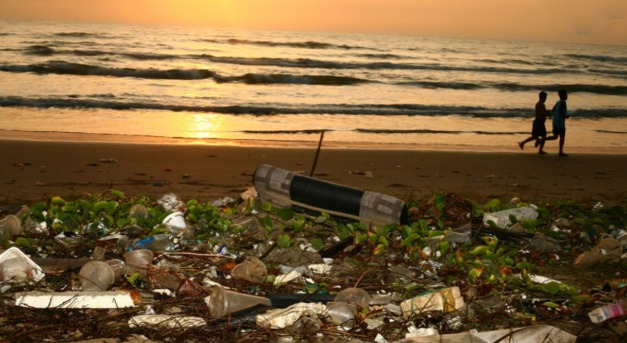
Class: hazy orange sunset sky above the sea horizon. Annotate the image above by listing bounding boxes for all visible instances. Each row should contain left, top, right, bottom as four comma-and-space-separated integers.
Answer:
0, 0, 627, 46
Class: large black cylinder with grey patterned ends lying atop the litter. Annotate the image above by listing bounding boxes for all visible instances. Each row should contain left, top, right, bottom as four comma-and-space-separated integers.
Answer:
253, 164, 407, 225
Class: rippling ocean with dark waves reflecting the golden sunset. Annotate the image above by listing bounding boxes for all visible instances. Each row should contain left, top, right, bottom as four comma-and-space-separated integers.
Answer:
0, 21, 627, 153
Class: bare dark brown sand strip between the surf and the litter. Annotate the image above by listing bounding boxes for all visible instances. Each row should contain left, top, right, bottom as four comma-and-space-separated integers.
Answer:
0, 133, 627, 211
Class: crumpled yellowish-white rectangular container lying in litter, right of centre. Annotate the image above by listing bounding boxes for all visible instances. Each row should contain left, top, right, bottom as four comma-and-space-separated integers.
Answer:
401, 287, 465, 317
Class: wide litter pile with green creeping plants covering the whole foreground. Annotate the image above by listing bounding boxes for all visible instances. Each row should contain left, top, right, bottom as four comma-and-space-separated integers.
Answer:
0, 167, 627, 342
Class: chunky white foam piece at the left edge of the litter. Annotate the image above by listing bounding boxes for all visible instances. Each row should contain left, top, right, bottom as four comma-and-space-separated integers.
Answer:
0, 247, 46, 282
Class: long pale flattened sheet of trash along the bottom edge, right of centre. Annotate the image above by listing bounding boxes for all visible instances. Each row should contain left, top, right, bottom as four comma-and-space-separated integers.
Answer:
398, 325, 577, 343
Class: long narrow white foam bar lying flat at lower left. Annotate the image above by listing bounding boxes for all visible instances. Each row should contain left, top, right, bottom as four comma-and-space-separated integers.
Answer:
15, 291, 135, 308
